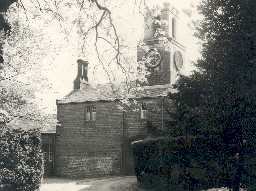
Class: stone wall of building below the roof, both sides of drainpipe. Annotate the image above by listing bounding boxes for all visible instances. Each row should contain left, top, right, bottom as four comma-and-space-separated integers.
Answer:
55, 99, 172, 177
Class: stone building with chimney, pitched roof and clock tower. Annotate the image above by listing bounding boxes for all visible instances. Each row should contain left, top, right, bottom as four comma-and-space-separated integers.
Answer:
55, 5, 186, 177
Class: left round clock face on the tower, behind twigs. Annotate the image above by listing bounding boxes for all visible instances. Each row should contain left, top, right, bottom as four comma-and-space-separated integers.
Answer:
145, 48, 162, 68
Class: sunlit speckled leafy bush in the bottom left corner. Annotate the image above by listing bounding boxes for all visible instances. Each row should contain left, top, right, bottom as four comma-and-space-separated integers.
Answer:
0, 124, 43, 191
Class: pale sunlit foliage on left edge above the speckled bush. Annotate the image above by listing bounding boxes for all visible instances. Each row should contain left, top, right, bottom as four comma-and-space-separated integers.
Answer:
0, 0, 47, 116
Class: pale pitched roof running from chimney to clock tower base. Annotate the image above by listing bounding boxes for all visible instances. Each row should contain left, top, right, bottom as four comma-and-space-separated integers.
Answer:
57, 84, 174, 104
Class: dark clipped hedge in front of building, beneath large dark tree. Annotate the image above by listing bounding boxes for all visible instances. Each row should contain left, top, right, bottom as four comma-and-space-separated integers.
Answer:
132, 137, 256, 191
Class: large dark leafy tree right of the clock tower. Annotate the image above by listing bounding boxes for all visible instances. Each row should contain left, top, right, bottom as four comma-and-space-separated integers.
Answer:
173, 0, 256, 191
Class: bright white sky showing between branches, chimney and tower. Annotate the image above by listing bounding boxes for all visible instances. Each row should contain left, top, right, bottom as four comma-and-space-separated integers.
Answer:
7, 0, 202, 113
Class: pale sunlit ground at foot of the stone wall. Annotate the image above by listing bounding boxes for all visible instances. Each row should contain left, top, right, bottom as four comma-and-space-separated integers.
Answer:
40, 176, 137, 191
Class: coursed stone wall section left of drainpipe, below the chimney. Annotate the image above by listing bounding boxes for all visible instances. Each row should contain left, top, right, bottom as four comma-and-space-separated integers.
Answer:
56, 102, 122, 177
